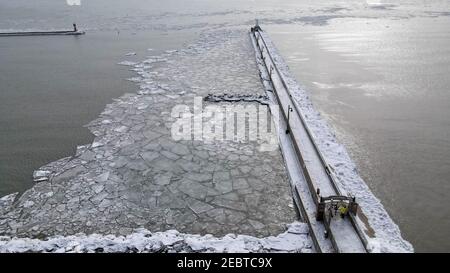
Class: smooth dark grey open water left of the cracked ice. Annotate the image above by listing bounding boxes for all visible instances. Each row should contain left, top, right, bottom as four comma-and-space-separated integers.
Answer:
0, 31, 195, 195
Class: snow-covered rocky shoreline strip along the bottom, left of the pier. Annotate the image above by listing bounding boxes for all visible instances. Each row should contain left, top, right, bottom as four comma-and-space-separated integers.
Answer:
0, 222, 313, 253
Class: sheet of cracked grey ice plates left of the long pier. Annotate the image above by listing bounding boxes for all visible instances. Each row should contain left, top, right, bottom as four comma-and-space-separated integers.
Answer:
0, 29, 296, 238
